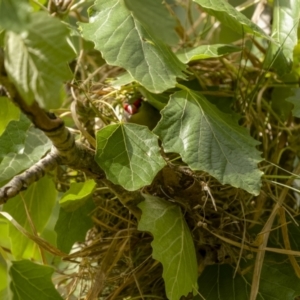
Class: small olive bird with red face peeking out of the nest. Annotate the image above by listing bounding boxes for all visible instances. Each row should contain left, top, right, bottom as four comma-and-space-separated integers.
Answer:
123, 98, 160, 130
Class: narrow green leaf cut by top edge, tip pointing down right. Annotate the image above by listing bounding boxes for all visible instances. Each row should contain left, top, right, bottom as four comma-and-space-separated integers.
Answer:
194, 0, 271, 40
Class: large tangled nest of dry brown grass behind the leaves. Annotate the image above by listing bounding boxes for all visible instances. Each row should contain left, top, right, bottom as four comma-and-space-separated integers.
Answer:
55, 35, 300, 300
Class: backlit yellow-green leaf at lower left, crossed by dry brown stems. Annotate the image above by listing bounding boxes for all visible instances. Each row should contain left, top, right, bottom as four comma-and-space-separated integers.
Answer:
3, 176, 57, 259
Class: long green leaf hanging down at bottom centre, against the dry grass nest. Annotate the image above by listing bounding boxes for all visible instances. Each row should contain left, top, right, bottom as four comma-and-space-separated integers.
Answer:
138, 195, 197, 300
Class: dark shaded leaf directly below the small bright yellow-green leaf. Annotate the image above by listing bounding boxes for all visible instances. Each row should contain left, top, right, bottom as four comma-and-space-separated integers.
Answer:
55, 199, 95, 253
